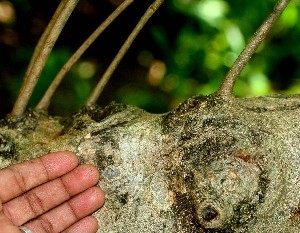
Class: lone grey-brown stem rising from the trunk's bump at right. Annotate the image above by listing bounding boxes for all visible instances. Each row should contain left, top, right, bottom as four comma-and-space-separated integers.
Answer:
216, 0, 290, 98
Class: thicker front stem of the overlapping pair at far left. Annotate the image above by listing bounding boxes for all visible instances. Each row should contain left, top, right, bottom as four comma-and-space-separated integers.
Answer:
11, 0, 79, 117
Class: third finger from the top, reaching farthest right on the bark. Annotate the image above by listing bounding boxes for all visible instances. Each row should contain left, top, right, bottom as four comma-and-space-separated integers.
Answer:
25, 187, 104, 233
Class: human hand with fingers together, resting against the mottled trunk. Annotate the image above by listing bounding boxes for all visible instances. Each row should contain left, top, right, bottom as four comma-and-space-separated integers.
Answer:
0, 151, 104, 233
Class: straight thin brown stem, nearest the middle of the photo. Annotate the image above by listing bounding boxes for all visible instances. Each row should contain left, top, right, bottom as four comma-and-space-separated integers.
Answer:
85, 0, 164, 106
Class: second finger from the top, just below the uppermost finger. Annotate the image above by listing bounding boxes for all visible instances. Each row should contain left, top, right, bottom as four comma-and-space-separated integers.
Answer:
3, 165, 99, 225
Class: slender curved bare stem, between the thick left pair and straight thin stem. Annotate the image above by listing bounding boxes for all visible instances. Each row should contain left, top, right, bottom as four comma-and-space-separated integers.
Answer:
35, 0, 134, 110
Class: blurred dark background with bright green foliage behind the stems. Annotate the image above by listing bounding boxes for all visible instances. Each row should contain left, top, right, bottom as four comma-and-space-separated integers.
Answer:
0, 0, 300, 116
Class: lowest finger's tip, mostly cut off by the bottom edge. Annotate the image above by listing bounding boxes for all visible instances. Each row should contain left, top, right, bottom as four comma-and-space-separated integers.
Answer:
62, 216, 98, 233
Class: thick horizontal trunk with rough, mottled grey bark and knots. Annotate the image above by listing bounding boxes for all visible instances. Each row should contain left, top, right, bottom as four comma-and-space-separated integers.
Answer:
0, 95, 300, 233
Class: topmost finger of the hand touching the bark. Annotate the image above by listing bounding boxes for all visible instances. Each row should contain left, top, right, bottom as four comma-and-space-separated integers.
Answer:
0, 151, 78, 203
